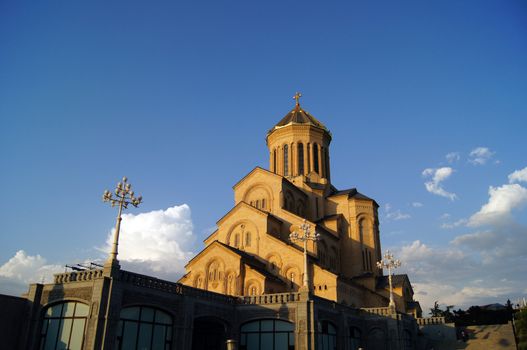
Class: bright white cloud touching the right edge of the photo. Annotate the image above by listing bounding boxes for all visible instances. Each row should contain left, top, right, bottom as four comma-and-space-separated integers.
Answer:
468, 184, 527, 226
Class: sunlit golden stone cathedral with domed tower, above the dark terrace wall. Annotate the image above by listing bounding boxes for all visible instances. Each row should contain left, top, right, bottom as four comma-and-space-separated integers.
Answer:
180, 94, 420, 315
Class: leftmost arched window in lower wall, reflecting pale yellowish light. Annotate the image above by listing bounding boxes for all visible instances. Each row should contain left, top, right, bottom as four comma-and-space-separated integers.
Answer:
40, 301, 89, 350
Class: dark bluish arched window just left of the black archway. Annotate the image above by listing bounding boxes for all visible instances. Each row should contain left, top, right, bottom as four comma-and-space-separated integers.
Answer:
115, 306, 172, 350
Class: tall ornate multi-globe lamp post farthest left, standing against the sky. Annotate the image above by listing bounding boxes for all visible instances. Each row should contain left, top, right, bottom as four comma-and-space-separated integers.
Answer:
102, 176, 143, 266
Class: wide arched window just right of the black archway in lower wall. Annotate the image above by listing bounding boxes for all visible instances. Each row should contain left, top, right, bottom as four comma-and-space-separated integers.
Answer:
240, 320, 295, 350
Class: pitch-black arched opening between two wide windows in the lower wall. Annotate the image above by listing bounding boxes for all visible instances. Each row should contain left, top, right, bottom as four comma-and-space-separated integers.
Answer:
192, 317, 228, 350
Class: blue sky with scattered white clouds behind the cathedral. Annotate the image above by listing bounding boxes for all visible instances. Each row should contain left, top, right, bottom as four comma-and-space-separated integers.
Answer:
0, 0, 527, 307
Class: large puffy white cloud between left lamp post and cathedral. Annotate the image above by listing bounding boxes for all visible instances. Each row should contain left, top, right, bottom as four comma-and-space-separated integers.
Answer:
105, 204, 196, 279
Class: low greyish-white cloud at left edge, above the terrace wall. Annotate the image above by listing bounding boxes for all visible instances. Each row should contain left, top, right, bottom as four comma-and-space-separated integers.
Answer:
0, 250, 64, 294
